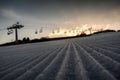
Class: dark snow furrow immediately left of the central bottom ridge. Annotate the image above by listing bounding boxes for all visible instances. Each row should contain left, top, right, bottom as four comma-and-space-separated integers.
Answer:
35, 41, 70, 80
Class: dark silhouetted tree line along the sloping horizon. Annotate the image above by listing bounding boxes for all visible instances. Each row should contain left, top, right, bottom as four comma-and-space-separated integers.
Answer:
0, 29, 120, 46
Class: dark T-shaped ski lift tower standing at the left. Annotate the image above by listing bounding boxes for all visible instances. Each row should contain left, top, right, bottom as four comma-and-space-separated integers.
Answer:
7, 22, 24, 42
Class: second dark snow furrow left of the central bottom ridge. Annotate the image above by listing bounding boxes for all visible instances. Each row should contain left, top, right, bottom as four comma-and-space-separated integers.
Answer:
15, 42, 69, 80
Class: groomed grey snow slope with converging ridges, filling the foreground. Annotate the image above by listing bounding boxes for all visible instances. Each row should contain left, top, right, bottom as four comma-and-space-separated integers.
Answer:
0, 32, 120, 80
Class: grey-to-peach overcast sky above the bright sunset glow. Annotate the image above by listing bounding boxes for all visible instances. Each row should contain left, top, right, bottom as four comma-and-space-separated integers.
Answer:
0, 0, 120, 42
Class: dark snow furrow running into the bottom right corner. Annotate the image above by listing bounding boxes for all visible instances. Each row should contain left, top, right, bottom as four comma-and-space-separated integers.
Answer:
79, 45, 120, 78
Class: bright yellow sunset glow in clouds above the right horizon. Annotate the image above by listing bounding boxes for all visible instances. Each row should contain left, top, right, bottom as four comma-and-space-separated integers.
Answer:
48, 24, 116, 38
